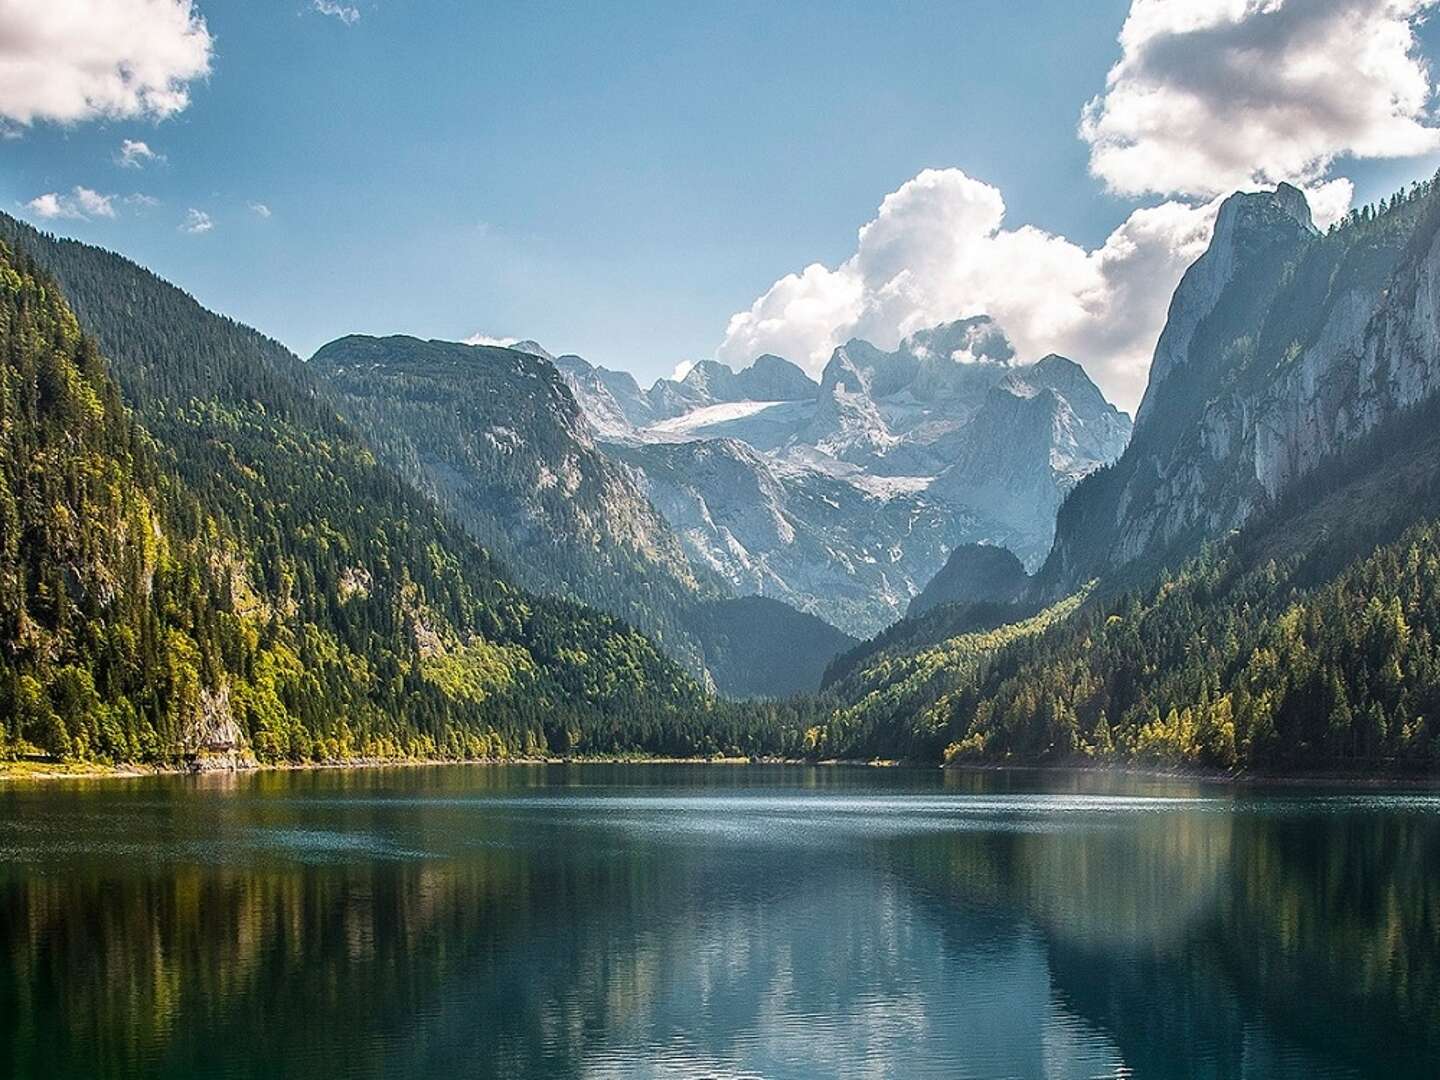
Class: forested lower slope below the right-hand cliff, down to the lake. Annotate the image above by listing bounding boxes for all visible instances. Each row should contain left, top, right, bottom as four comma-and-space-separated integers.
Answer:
808, 388, 1440, 772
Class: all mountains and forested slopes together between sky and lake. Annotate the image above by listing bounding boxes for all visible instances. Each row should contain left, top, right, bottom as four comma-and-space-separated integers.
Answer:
8, 183, 1440, 772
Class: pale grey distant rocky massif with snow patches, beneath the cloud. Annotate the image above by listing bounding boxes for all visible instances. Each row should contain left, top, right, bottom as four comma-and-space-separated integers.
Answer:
544, 315, 1130, 635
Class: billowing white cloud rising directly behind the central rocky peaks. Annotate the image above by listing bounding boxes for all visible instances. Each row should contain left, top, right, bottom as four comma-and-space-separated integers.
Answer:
717, 168, 1238, 408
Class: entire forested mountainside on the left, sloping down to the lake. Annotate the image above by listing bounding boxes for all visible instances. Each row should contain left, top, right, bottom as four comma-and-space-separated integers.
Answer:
0, 217, 794, 760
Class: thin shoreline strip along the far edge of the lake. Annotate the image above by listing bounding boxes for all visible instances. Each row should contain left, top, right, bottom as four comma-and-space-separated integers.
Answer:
0, 755, 1440, 789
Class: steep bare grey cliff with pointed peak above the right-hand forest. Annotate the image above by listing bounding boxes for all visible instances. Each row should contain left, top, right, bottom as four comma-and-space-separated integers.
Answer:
1040, 184, 1440, 592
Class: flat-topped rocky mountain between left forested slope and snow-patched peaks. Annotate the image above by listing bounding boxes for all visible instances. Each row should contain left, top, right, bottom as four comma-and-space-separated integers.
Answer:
310, 334, 726, 677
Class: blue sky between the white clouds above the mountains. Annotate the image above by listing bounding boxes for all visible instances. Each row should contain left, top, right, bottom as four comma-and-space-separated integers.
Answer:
8, 0, 1437, 408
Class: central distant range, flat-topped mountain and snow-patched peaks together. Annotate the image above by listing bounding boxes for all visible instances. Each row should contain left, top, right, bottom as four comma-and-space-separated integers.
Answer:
298, 318, 1129, 693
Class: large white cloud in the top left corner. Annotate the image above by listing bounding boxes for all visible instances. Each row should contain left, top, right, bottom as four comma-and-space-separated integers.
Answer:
0, 0, 213, 125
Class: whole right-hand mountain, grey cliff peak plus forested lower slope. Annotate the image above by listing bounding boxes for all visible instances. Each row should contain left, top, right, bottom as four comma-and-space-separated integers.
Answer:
812, 181, 1440, 772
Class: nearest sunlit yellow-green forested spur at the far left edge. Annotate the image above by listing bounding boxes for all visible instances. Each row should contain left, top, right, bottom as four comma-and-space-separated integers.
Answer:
0, 237, 239, 760
